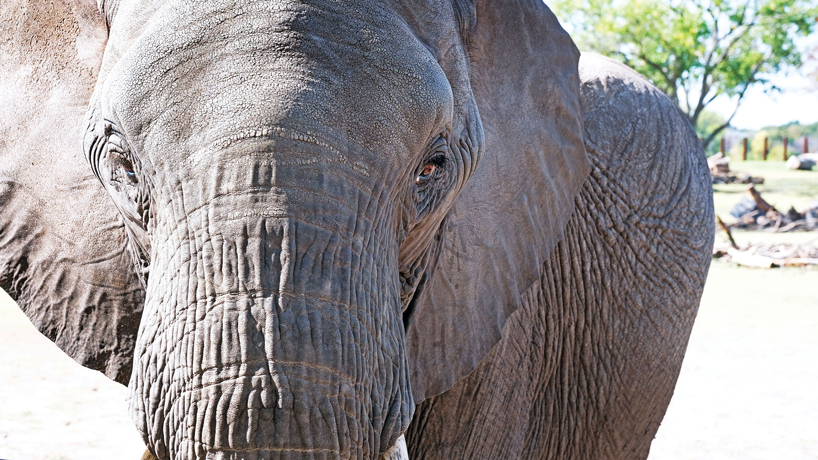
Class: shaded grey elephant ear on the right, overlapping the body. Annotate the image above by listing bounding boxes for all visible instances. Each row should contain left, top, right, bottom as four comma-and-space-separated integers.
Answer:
406, 0, 589, 403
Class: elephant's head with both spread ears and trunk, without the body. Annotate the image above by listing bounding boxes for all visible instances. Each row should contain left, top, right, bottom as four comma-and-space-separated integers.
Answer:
0, 0, 588, 459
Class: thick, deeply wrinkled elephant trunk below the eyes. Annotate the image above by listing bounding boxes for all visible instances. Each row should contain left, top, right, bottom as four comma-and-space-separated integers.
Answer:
130, 174, 414, 459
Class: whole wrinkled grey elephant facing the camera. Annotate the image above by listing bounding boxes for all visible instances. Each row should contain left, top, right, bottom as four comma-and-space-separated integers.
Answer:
0, 0, 714, 460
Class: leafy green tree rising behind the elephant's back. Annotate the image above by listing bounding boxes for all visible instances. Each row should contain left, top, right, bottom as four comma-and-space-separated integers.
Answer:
549, 0, 818, 148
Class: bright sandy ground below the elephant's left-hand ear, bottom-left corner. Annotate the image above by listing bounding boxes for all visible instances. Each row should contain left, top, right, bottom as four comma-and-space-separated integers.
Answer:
0, 290, 145, 460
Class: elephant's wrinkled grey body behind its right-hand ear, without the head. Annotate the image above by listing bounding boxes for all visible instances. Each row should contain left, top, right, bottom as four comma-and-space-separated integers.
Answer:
407, 54, 713, 459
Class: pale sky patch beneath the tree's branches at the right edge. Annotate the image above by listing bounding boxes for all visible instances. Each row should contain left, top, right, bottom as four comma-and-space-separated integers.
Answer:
708, 73, 818, 130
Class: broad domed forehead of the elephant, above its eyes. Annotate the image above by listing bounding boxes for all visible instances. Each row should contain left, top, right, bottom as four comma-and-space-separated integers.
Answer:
105, 1, 454, 162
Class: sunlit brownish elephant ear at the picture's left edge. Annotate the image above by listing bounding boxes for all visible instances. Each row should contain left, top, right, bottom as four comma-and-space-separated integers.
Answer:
0, 0, 144, 384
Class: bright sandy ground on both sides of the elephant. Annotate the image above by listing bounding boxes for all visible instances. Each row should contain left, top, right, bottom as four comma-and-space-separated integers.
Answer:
0, 262, 818, 460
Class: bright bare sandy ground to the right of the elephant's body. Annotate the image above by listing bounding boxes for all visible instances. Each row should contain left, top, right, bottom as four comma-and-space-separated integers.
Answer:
649, 261, 818, 460
